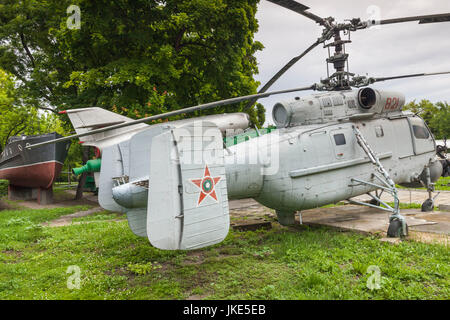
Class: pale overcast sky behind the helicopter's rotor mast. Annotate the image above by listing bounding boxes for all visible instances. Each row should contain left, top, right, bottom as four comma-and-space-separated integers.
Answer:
255, 0, 450, 124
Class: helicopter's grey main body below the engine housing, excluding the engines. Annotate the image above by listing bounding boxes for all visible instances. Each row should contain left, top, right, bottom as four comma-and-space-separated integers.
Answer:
225, 112, 435, 211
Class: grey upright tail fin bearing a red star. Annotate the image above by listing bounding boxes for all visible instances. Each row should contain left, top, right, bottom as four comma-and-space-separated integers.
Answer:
147, 121, 230, 250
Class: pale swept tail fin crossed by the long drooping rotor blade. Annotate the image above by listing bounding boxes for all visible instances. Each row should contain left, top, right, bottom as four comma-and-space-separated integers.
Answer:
66, 107, 148, 150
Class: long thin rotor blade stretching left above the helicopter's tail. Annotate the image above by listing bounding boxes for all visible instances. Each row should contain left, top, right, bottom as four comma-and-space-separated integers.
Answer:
26, 84, 316, 149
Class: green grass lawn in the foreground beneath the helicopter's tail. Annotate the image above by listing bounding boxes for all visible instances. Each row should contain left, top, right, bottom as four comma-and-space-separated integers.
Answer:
0, 207, 450, 299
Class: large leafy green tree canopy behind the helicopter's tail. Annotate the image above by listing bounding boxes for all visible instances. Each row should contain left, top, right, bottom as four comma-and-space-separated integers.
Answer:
0, 0, 264, 124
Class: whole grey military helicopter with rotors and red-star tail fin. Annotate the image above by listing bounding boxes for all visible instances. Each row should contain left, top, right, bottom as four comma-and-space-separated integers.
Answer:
29, 0, 450, 250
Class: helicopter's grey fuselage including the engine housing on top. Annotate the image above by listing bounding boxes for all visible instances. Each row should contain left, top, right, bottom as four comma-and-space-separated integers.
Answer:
225, 88, 440, 222
